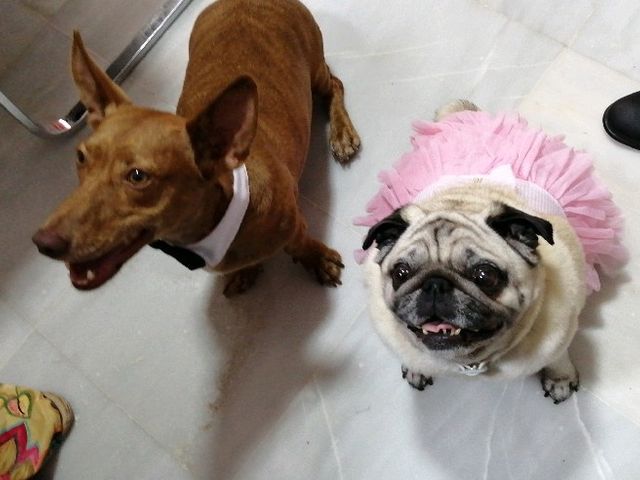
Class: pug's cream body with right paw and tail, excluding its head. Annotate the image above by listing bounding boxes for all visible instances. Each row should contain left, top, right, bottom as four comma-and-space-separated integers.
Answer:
364, 101, 586, 402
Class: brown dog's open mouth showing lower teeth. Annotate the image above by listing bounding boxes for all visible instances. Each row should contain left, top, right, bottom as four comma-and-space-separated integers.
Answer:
67, 230, 152, 290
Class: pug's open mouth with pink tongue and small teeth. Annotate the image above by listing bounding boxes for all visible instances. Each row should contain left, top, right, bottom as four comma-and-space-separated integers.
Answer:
405, 318, 502, 350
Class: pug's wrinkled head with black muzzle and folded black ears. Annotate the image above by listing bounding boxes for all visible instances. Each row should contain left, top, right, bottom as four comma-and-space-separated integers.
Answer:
363, 204, 553, 357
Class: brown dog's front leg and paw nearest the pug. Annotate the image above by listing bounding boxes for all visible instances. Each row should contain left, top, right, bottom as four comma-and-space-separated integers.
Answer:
284, 214, 344, 287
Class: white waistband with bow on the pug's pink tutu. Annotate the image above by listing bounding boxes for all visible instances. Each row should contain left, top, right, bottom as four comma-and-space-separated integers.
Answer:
414, 165, 565, 217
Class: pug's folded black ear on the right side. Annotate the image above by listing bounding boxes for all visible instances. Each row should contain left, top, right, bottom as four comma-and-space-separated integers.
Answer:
487, 205, 553, 264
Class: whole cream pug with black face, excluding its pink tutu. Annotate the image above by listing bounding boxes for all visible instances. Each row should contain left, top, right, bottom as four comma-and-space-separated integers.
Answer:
363, 102, 587, 404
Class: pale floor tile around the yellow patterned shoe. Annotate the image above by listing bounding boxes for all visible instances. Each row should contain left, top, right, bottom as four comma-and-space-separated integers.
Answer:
0, 333, 192, 480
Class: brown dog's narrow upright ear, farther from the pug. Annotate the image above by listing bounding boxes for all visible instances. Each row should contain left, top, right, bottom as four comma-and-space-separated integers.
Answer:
71, 30, 131, 129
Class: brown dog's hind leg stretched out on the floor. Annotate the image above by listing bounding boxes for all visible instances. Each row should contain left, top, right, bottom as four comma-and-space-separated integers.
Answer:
314, 62, 360, 164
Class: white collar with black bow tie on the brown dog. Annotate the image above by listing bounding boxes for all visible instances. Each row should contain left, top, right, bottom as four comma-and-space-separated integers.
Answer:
149, 163, 251, 270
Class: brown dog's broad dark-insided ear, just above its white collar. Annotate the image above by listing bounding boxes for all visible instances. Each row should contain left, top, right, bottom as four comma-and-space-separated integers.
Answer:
187, 77, 258, 178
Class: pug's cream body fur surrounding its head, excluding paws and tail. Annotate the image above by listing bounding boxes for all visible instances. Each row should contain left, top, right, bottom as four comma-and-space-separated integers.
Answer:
364, 185, 586, 378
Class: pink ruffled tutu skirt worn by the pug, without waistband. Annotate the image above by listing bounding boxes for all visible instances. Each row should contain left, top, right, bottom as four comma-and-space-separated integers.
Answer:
354, 111, 627, 291
